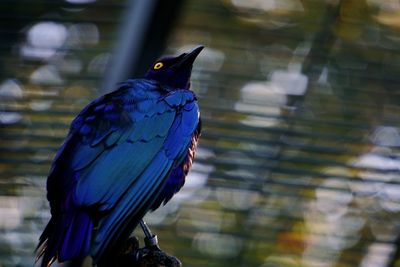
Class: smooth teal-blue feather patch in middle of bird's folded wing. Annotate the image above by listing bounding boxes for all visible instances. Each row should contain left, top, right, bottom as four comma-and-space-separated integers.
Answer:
74, 137, 164, 210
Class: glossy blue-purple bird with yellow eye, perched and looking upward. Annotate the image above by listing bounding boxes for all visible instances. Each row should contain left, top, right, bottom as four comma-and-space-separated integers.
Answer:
36, 46, 204, 267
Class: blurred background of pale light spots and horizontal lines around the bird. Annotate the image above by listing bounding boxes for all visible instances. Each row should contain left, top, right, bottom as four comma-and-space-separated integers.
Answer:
0, 0, 400, 267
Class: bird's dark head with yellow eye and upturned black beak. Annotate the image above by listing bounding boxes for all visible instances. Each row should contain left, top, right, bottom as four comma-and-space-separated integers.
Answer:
144, 46, 204, 89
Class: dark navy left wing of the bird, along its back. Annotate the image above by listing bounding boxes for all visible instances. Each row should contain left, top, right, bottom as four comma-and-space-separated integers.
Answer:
47, 85, 135, 215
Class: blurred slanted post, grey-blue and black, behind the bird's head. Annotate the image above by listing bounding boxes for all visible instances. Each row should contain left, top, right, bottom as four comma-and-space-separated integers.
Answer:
101, 0, 183, 93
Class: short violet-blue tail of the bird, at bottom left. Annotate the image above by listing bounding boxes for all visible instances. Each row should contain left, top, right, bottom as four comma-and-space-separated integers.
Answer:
36, 210, 93, 267
